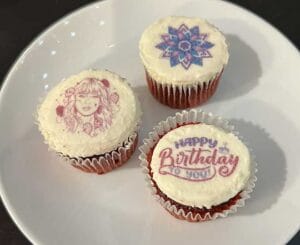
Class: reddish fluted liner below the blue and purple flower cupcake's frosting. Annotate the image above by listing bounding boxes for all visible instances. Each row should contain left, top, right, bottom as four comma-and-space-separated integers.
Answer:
145, 70, 223, 109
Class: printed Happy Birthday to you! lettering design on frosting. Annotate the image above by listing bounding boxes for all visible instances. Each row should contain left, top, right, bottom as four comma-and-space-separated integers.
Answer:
159, 137, 239, 181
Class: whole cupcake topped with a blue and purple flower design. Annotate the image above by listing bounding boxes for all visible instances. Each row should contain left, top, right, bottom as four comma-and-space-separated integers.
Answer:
139, 16, 229, 109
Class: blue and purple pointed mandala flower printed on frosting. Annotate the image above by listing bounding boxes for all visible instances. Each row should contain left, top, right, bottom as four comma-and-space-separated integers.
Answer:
155, 24, 214, 70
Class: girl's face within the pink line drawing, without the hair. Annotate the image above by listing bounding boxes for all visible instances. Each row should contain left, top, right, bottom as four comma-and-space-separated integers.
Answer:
75, 93, 100, 116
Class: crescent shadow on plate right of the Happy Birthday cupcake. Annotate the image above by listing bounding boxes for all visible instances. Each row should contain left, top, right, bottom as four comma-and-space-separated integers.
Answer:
230, 119, 287, 215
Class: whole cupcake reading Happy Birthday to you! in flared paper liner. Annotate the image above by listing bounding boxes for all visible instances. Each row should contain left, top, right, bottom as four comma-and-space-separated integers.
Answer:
140, 110, 256, 222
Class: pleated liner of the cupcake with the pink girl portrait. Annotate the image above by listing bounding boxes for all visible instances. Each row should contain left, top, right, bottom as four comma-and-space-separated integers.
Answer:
58, 132, 138, 174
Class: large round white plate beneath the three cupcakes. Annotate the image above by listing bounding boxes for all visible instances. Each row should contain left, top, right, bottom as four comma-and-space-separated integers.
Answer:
0, 0, 300, 245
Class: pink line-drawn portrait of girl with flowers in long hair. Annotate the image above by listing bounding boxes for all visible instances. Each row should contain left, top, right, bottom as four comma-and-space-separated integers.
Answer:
56, 78, 119, 137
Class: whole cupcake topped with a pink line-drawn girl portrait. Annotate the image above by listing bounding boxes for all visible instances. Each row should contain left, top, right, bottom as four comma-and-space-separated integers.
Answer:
36, 70, 141, 174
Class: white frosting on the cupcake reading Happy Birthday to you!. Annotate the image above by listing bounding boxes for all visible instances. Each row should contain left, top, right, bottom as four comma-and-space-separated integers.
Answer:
151, 124, 251, 208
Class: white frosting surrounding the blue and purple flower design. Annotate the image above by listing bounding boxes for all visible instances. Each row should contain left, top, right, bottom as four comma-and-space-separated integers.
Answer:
139, 16, 229, 85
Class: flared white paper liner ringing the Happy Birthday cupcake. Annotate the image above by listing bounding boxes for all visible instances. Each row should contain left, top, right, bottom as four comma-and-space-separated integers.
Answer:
139, 109, 257, 222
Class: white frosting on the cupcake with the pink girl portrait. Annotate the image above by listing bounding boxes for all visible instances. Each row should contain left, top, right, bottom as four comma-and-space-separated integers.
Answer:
37, 70, 141, 157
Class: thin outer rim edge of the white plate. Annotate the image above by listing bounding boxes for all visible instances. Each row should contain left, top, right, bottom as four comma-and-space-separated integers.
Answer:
0, 0, 300, 244
